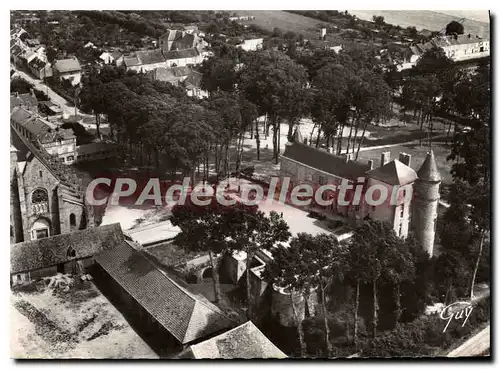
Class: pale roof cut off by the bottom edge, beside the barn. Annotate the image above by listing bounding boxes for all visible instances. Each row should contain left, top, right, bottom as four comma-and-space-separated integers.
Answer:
182, 321, 287, 359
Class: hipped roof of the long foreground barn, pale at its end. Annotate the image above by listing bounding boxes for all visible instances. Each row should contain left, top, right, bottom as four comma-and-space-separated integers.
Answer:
95, 243, 233, 344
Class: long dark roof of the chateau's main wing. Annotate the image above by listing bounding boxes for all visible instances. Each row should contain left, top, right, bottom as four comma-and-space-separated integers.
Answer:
283, 142, 370, 179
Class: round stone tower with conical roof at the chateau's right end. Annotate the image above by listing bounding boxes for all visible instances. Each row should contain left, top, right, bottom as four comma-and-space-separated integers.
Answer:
412, 150, 441, 256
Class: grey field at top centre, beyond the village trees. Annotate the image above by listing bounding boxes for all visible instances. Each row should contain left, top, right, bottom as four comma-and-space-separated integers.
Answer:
235, 10, 321, 39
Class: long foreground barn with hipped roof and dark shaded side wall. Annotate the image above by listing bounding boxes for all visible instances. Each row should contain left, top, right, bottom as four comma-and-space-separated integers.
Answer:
94, 242, 235, 356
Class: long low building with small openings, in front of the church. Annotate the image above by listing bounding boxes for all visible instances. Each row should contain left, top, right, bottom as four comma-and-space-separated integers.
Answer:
10, 223, 125, 285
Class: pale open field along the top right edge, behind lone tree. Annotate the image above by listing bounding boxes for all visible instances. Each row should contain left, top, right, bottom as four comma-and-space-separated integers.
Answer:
349, 10, 489, 37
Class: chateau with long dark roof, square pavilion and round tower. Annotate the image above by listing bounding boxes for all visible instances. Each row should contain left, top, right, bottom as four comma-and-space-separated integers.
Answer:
280, 130, 441, 256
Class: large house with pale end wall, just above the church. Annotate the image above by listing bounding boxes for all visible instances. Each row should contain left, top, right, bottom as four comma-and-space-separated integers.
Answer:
10, 107, 77, 164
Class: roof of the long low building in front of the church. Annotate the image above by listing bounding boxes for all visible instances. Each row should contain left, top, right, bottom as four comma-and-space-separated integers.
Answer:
10, 223, 125, 274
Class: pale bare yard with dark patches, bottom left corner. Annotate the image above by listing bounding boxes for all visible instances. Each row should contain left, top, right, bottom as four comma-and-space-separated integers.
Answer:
10, 281, 158, 359
